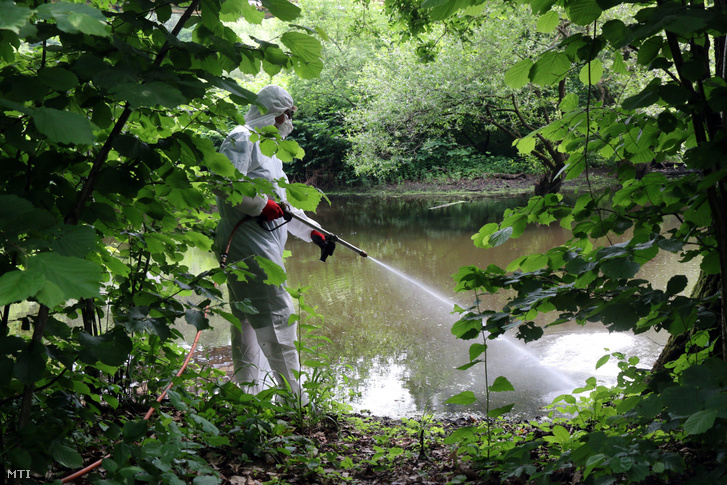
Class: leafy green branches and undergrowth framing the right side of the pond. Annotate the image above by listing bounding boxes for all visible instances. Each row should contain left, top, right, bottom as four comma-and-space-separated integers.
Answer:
392, 0, 727, 483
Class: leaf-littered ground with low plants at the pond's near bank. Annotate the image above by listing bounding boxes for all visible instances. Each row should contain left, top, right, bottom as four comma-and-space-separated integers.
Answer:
208, 414, 540, 485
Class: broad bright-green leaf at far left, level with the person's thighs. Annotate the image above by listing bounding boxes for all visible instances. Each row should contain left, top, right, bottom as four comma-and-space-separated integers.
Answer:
27, 253, 102, 299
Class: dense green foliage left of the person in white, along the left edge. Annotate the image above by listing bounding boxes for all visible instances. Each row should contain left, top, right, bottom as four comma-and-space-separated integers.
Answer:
0, 0, 322, 480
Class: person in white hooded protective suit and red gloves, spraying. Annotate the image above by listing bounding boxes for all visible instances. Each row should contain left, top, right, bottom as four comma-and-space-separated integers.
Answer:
215, 85, 333, 404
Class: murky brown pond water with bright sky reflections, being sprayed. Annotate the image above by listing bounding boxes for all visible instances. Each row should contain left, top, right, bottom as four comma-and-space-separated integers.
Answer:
180, 196, 698, 417
